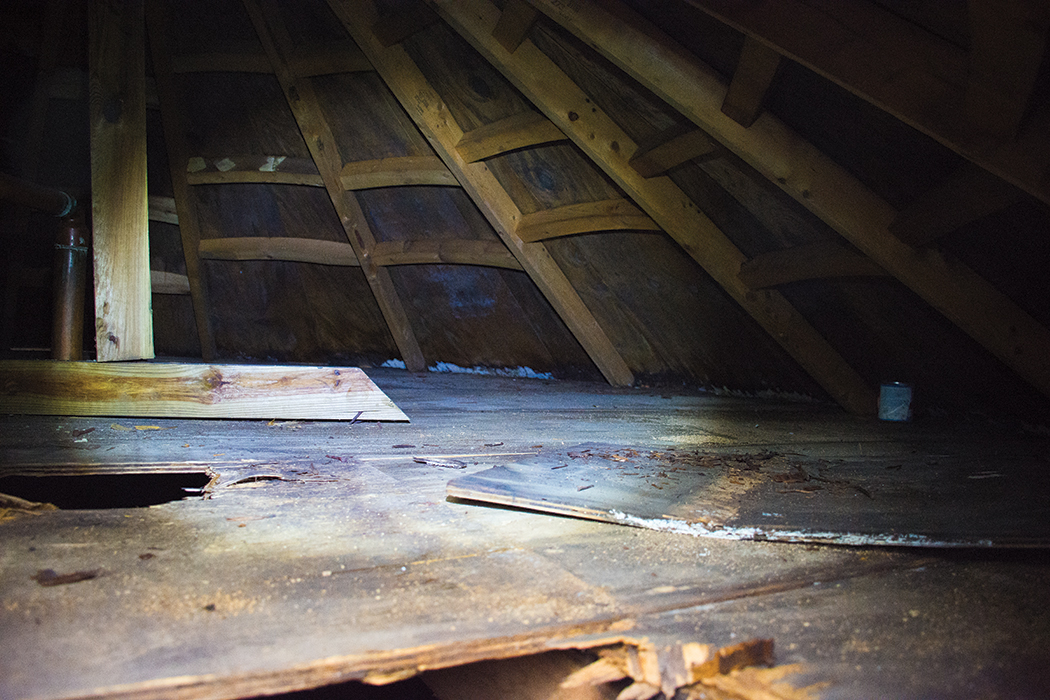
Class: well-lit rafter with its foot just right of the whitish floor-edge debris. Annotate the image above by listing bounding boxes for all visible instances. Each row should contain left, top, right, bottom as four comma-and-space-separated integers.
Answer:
329, 0, 634, 385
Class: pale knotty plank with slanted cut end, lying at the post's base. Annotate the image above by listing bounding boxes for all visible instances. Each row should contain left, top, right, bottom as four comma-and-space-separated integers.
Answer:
0, 360, 408, 421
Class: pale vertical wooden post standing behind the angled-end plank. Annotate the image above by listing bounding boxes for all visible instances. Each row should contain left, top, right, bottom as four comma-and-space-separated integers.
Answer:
88, 0, 153, 361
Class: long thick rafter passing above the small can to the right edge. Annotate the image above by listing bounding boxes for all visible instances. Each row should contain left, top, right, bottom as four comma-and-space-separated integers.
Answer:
533, 0, 1050, 405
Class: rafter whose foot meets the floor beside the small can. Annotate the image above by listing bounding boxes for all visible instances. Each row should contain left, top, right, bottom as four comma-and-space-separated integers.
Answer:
437, 0, 875, 413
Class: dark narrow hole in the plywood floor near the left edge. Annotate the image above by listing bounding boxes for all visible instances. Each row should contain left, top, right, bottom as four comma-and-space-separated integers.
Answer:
0, 471, 210, 510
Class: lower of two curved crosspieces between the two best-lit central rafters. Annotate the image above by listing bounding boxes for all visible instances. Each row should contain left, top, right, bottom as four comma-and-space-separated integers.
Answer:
515, 197, 660, 242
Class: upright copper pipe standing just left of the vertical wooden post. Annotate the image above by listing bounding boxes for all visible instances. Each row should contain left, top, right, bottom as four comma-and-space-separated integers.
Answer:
51, 212, 87, 360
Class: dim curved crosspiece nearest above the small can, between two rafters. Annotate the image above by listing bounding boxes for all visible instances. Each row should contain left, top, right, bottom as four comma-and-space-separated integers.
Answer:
740, 240, 888, 290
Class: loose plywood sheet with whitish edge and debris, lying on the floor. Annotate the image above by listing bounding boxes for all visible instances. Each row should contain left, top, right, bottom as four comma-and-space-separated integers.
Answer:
447, 444, 1050, 547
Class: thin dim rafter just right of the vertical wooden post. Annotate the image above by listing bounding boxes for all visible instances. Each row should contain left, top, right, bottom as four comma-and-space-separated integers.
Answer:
146, 0, 216, 360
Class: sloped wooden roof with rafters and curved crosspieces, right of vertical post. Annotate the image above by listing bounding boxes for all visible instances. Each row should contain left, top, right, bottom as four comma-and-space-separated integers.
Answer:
2, 0, 1050, 420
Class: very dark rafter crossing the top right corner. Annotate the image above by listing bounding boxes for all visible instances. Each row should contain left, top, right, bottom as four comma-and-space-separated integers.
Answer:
680, 0, 1050, 204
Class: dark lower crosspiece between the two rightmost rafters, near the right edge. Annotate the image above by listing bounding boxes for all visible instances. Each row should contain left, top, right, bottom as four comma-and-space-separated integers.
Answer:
889, 163, 1024, 246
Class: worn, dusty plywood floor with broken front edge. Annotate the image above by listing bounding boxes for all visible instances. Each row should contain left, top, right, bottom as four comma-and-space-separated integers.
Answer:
0, 370, 1050, 700
